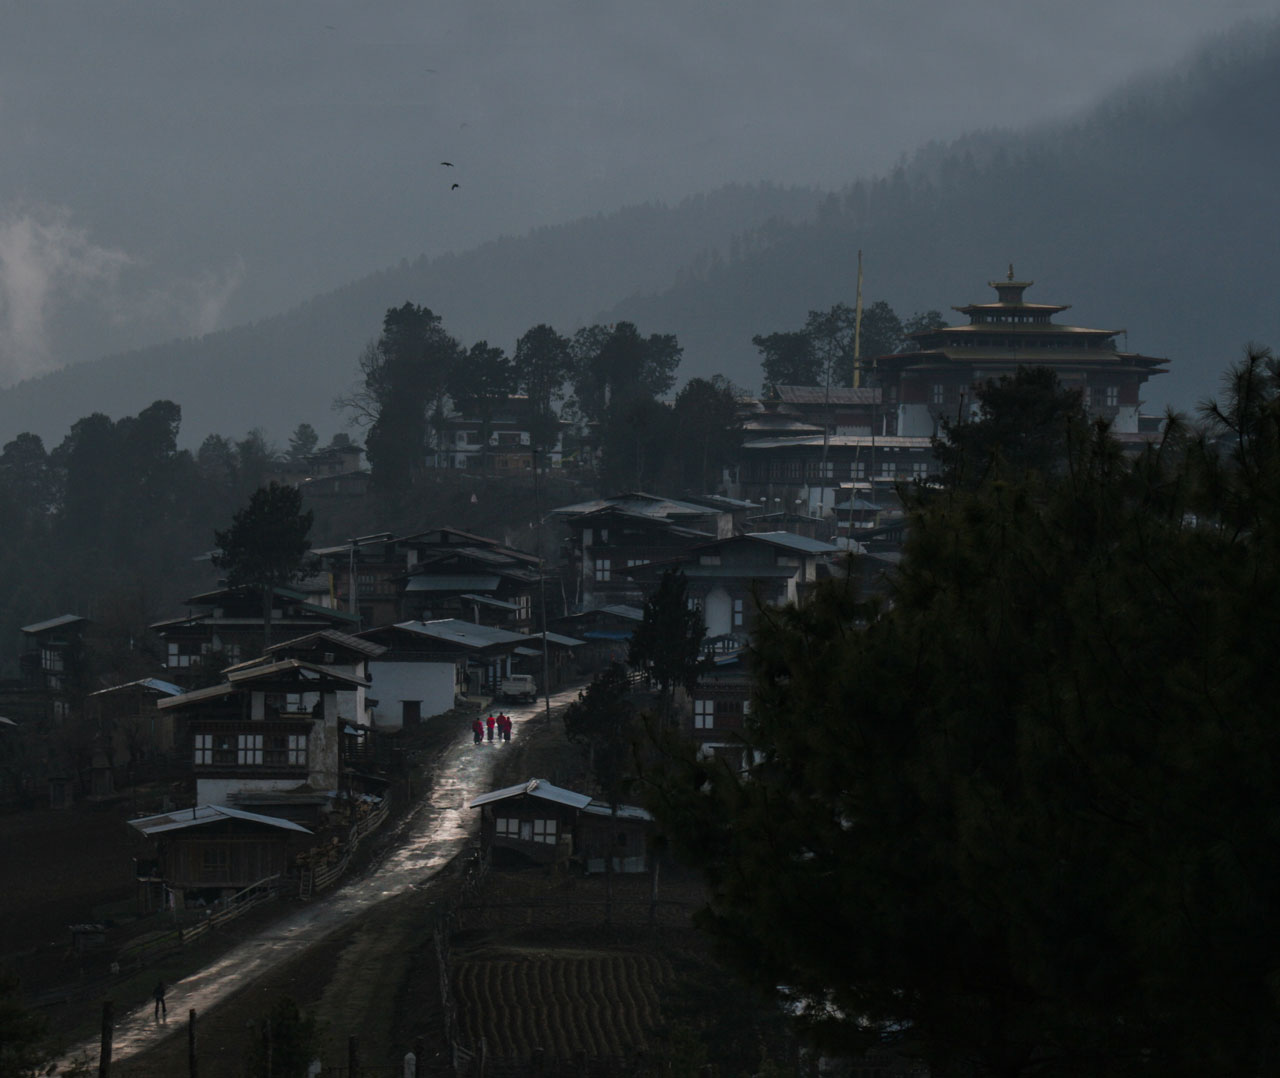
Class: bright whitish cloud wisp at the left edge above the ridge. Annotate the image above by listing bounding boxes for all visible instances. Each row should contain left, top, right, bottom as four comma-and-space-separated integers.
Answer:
0, 206, 132, 382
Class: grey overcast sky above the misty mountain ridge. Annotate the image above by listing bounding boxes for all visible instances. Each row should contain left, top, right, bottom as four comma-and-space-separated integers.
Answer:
0, 0, 1280, 384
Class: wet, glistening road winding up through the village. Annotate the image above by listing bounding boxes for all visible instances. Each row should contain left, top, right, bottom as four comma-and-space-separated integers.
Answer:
61, 688, 579, 1066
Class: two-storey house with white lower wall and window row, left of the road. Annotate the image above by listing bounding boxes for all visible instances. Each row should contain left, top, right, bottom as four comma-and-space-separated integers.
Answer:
159, 659, 369, 826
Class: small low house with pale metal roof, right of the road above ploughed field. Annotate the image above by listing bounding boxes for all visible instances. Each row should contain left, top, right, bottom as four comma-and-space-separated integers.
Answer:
470, 778, 652, 872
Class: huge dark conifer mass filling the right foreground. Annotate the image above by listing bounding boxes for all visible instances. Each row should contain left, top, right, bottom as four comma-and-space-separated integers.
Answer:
640, 348, 1280, 1078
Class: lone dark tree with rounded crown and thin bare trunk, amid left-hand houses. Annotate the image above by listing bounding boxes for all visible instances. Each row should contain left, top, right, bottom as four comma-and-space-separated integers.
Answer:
214, 483, 314, 649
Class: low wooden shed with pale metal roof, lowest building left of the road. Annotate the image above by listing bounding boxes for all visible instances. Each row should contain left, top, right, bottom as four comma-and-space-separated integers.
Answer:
129, 804, 312, 909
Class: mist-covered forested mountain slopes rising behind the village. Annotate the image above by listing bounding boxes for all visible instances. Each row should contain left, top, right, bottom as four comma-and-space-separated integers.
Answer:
0, 27, 1280, 443
